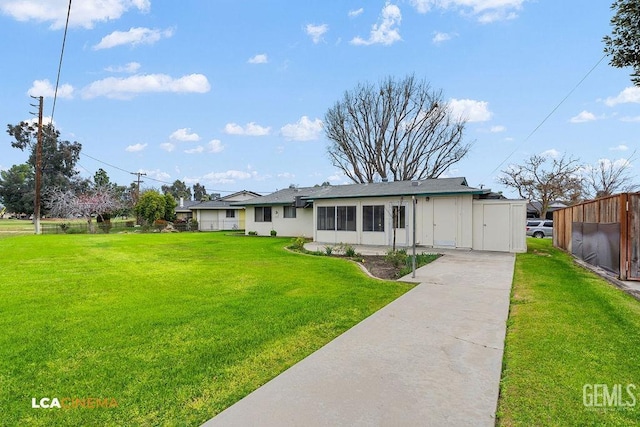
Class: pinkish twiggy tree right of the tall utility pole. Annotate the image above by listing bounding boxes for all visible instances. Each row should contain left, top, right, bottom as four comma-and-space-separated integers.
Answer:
45, 187, 122, 233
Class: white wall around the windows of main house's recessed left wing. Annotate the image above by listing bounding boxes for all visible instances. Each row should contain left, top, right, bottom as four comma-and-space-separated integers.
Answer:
245, 206, 314, 237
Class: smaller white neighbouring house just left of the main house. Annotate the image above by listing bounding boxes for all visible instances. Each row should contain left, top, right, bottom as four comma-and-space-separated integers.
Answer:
190, 190, 260, 231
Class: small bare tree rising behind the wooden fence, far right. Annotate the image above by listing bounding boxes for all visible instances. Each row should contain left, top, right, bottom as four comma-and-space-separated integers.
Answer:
584, 151, 638, 198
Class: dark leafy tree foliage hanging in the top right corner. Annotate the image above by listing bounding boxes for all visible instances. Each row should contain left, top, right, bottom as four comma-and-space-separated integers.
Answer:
603, 0, 640, 86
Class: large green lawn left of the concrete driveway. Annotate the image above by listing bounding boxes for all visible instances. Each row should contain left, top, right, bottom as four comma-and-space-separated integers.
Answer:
0, 233, 410, 426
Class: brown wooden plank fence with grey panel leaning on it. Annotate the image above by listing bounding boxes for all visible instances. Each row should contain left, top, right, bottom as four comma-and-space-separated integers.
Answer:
553, 193, 640, 280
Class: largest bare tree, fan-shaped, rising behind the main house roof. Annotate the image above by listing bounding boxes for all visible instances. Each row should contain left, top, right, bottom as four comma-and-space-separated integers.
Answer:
325, 76, 471, 183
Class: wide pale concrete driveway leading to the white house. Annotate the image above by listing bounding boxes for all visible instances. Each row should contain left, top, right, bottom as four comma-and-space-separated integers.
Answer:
204, 250, 515, 427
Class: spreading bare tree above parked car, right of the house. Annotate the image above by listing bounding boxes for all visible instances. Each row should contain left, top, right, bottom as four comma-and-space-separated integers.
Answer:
498, 155, 582, 218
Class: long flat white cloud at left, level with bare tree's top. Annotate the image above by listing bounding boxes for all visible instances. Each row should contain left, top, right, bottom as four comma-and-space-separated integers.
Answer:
82, 74, 211, 99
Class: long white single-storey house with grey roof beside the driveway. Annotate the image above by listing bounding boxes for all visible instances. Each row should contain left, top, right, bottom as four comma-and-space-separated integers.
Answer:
244, 178, 527, 252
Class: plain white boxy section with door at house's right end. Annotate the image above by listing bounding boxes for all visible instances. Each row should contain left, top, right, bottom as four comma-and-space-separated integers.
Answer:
473, 200, 527, 252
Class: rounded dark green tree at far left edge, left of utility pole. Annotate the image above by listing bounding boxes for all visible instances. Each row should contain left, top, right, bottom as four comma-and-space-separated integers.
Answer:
0, 163, 35, 213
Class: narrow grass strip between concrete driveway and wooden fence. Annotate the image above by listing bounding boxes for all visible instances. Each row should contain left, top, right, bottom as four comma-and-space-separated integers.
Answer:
498, 239, 640, 426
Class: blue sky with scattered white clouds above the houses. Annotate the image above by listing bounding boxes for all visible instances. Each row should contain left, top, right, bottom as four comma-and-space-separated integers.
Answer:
0, 0, 640, 196
